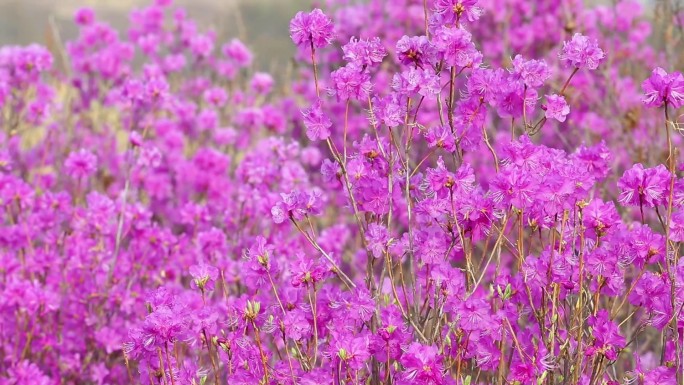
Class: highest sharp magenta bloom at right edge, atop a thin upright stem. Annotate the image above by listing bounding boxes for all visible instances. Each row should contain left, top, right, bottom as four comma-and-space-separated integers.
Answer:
641, 67, 684, 108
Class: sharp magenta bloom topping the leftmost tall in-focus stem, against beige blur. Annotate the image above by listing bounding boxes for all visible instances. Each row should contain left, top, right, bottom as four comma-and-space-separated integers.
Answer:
290, 8, 334, 48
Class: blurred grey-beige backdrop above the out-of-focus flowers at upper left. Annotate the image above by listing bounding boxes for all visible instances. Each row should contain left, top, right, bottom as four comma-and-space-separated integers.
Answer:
0, 0, 311, 70
